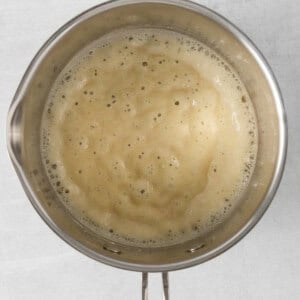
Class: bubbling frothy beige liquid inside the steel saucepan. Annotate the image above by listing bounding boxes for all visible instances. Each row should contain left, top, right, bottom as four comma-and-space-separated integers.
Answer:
42, 29, 257, 246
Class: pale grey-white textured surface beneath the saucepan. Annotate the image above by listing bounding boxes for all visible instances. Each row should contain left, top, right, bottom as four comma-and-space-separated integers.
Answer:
0, 0, 300, 300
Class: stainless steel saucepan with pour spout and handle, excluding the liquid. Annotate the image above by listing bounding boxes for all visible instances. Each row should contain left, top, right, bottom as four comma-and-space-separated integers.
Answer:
7, 0, 287, 299
